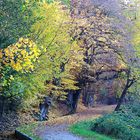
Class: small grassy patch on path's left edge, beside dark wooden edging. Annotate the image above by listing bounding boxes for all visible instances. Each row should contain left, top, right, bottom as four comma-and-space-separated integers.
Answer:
17, 123, 41, 140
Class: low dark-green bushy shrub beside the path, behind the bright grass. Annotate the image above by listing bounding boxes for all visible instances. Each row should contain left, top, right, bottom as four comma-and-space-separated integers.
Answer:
92, 112, 140, 140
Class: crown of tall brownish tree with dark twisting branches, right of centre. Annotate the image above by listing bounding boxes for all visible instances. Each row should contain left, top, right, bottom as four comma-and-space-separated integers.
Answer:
72, 1, 126, 107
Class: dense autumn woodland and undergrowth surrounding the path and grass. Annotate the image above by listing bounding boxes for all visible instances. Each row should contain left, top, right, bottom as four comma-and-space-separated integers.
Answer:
0, 0, 140, 140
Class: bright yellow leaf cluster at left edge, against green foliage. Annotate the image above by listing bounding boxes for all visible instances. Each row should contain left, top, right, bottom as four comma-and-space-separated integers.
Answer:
0, 38, 41, 72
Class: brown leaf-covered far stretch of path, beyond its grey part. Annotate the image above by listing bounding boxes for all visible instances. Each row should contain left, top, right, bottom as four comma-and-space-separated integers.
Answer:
44, 105, 115, 125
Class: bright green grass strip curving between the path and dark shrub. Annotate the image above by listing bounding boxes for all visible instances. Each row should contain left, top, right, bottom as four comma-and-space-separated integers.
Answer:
69, 120, 115, 140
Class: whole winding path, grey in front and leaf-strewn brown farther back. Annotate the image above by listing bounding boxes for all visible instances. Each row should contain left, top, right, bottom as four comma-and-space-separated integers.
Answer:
36, 105, 115, 140
